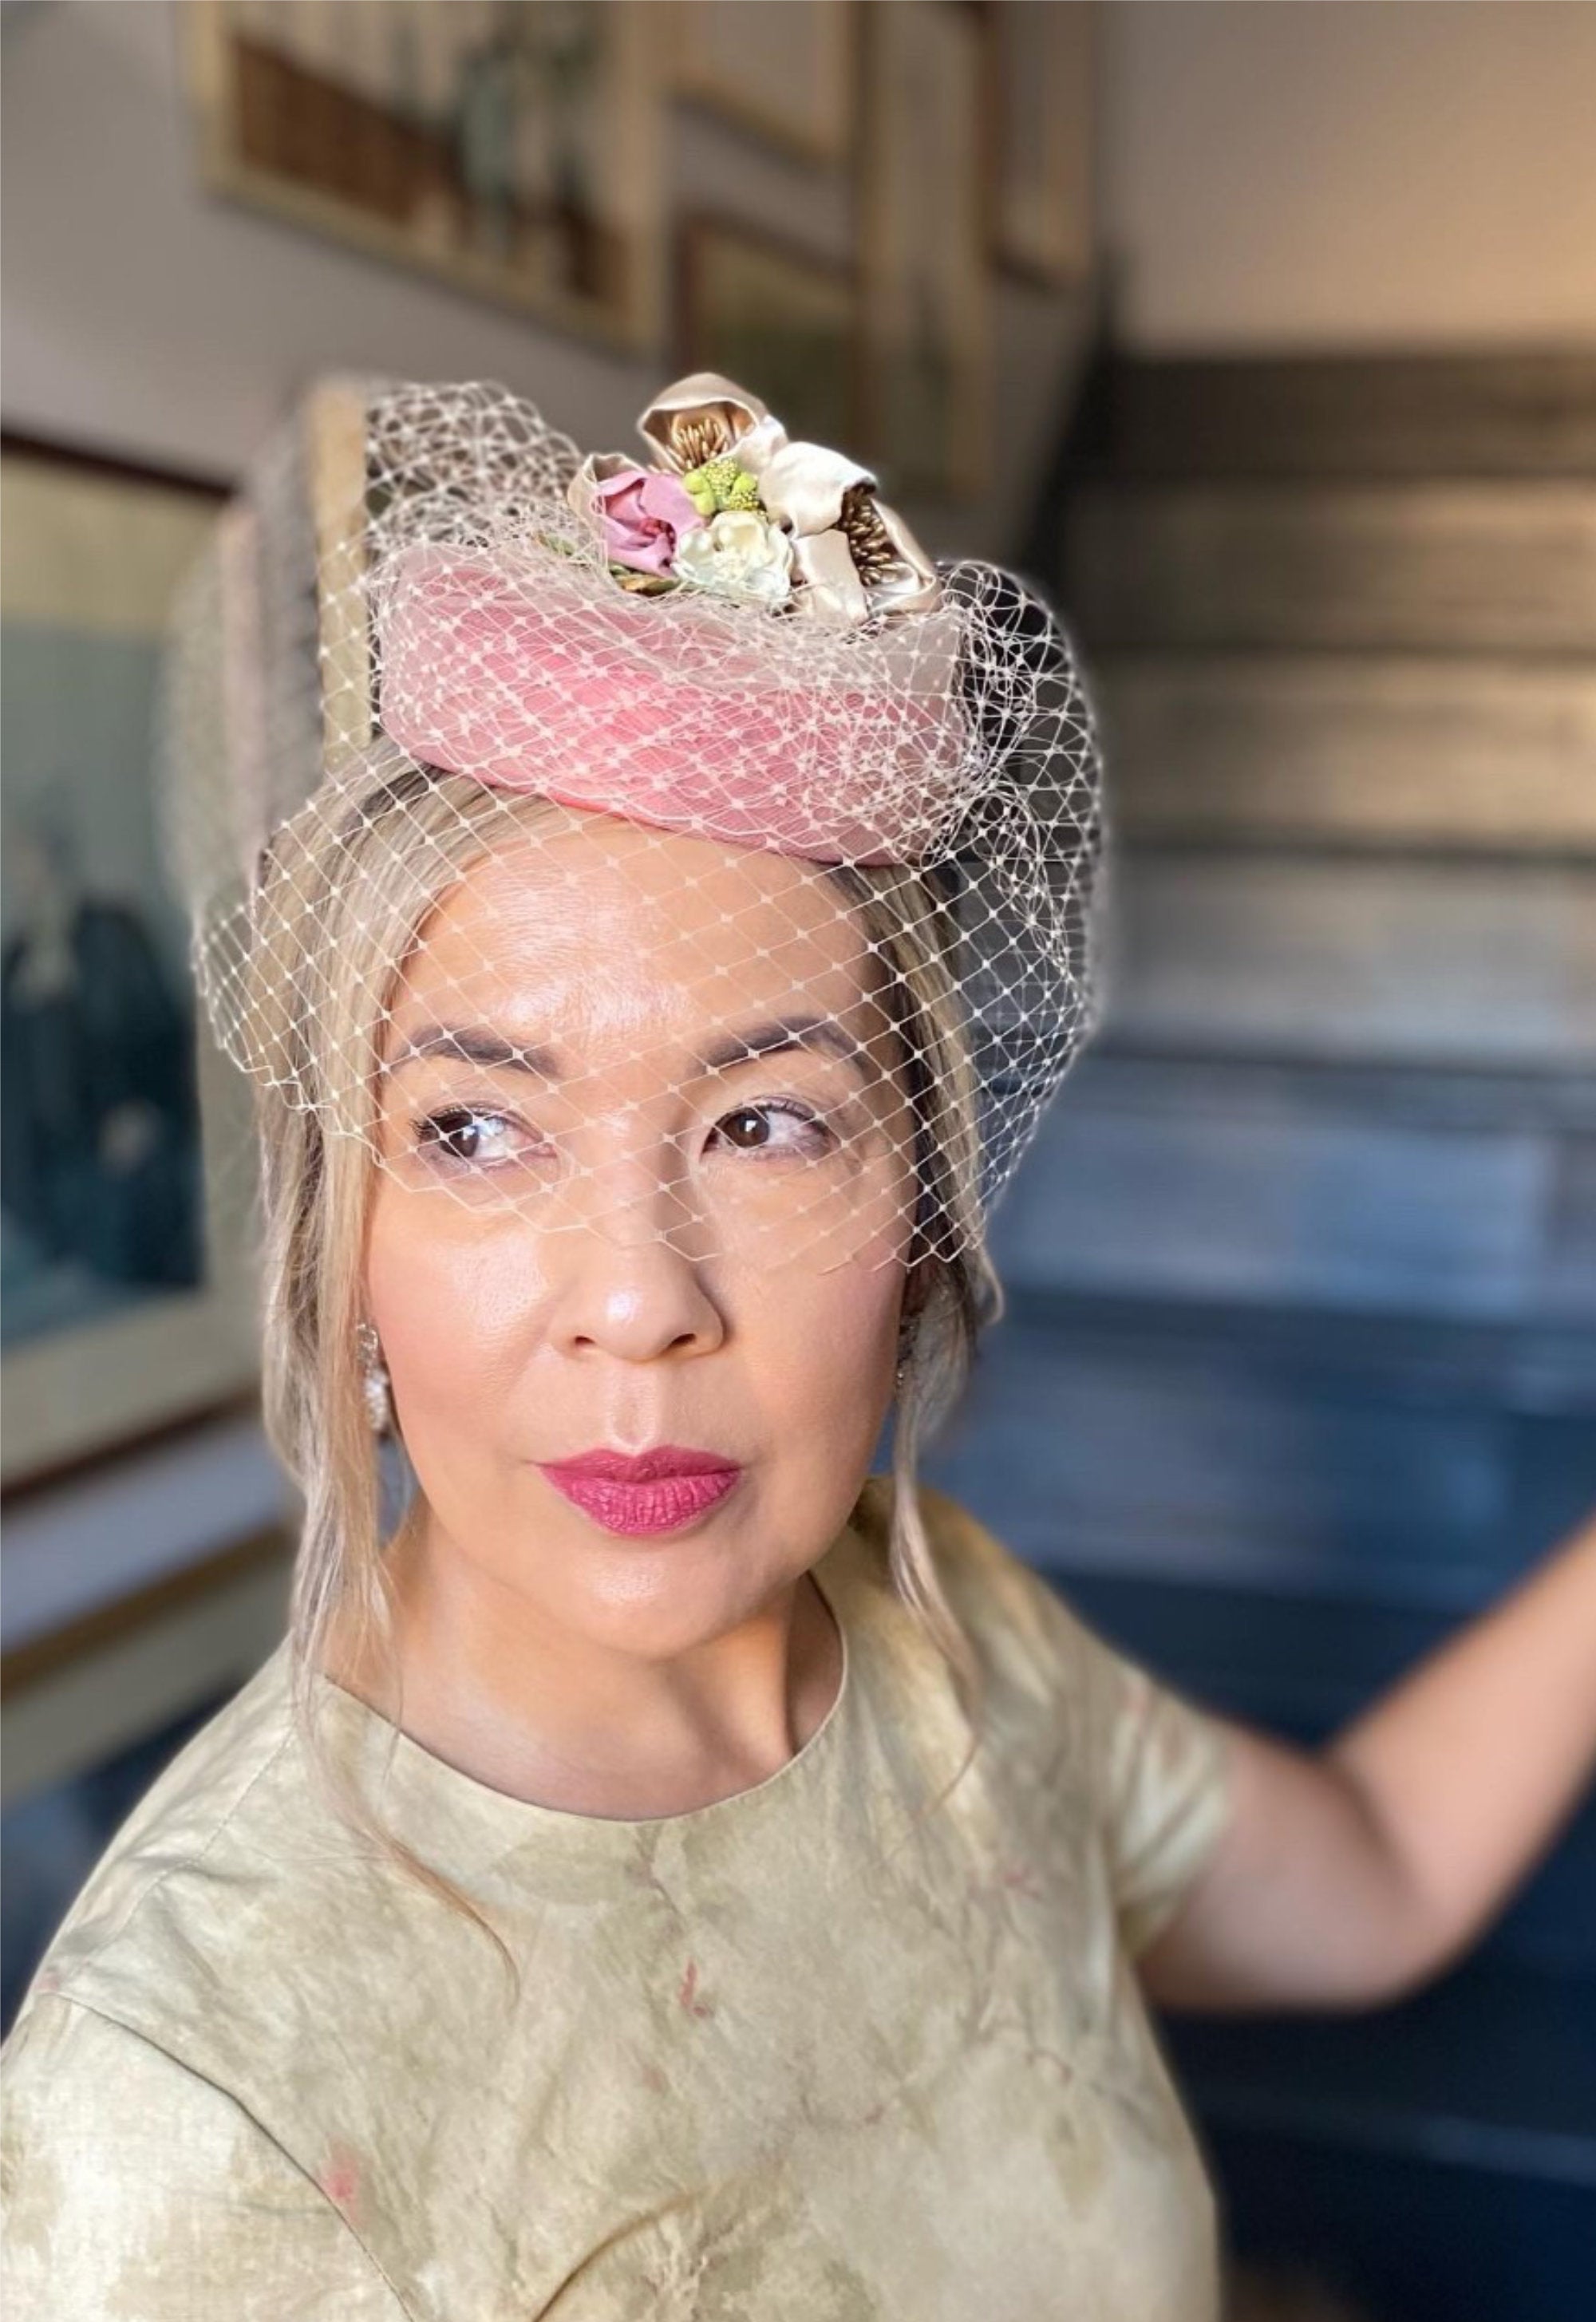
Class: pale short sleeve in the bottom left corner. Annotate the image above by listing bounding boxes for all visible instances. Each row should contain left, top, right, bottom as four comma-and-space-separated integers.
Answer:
0, 1995, 405, 2322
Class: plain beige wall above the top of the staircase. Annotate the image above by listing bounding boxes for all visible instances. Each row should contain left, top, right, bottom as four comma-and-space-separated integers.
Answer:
1099, 0, 1596, 353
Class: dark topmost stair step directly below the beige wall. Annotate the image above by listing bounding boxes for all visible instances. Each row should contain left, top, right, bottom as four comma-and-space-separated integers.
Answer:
1094, 349, 1596, 478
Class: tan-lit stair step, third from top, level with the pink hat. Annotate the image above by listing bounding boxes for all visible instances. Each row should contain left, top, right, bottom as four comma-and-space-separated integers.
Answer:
1087, 653, 1596, 855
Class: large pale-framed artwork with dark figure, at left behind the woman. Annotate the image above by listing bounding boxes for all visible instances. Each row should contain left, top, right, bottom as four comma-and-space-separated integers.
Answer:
0, 436, 258, 1486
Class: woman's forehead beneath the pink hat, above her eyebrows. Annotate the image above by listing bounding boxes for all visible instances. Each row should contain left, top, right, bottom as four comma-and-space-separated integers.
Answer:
393, 815, 876, 1045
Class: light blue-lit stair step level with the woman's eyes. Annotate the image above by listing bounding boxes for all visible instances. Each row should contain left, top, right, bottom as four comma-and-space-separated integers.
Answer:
992, 1068, 1596, 1330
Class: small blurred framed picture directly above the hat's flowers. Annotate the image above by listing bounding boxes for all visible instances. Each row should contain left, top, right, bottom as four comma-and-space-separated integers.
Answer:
681, 216, 859, 451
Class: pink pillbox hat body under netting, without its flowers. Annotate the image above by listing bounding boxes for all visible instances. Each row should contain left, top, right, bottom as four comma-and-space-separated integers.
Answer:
374, 541, 971, 864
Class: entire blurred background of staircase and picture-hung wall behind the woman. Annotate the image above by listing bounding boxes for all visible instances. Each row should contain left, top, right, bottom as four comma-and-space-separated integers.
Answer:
0, 0, 1596, 2322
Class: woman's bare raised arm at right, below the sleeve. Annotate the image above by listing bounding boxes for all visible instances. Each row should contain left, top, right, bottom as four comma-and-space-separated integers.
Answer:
1138, 1516, 1596, 2008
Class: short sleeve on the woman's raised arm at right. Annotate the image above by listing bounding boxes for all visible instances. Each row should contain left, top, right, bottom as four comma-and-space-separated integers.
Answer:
920, 1488, 1231, 1955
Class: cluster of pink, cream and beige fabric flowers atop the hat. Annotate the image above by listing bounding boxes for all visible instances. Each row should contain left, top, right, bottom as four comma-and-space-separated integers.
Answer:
567, 372, 941, 630
